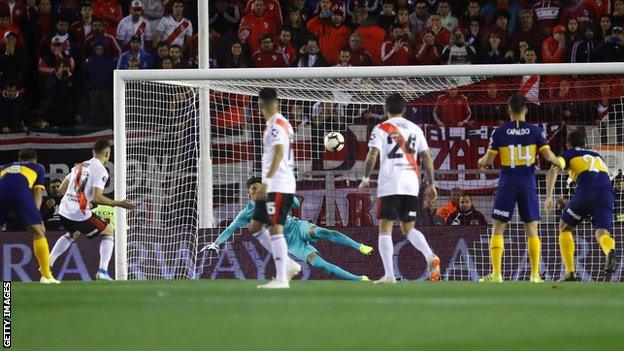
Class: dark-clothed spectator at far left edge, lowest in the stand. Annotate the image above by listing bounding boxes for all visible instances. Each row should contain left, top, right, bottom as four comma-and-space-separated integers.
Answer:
0, 81, 28, 133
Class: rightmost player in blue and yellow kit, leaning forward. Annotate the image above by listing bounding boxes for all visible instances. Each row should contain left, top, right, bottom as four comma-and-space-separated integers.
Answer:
544, 129, 617, 281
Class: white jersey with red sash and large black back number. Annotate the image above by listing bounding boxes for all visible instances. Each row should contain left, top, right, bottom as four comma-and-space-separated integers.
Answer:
368, 117, 429, 197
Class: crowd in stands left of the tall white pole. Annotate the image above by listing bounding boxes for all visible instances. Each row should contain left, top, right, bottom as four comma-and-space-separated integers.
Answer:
0, 0, 198, 133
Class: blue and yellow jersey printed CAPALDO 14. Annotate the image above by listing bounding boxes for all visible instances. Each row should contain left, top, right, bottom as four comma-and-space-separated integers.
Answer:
488, 121, 549, 186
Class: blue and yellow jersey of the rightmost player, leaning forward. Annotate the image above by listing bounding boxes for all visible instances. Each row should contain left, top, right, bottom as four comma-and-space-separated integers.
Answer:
559, 147, 612, 188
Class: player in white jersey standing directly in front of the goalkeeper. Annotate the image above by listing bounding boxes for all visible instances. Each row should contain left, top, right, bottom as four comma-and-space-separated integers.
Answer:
249, 88, 297, 289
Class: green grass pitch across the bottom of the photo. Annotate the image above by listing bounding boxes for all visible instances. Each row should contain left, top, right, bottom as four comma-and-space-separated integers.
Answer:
12, 280, 624, 351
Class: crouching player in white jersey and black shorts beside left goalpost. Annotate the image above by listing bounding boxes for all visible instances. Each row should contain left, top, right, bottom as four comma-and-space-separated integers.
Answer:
50, 139, 136, 280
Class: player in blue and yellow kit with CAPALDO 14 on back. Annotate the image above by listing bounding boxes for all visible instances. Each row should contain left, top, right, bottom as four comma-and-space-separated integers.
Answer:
478, 94, 560, 283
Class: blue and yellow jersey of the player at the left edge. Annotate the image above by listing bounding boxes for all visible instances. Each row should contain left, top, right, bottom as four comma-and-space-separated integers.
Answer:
0, 162, 45, 191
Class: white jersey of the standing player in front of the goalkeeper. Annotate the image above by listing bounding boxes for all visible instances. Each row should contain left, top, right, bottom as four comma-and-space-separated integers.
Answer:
262, 113, 297, 194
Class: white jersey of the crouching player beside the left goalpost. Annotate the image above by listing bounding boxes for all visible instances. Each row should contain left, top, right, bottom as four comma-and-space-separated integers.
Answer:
59, 158, 108, 222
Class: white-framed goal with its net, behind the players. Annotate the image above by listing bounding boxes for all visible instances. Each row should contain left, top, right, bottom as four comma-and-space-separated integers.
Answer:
114, 64, 624, 281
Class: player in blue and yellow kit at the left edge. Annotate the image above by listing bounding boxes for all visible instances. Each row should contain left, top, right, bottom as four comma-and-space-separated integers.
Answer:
0, 149, 59, 284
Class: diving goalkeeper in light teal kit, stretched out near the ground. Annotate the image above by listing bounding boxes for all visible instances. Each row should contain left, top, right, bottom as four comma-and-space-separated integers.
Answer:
200, 177, 373, 281
